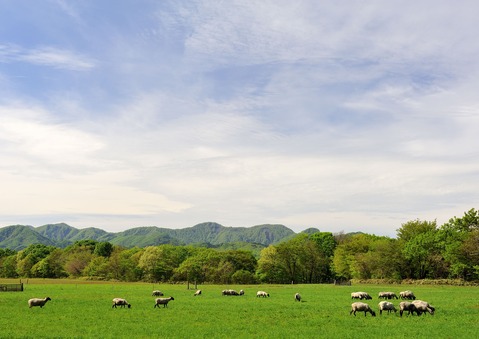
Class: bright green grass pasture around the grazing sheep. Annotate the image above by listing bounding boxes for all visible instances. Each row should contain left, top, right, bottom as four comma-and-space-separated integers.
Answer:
0, 280, 479, 338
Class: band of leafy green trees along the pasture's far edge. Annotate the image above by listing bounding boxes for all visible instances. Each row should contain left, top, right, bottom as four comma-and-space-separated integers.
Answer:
0, 209, 479, 284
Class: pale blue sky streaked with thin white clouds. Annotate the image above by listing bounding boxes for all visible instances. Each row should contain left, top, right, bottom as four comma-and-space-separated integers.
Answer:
0, 0, 479, 237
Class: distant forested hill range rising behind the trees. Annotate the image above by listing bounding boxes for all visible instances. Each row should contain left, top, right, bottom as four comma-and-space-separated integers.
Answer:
0, 222, 295, 250
